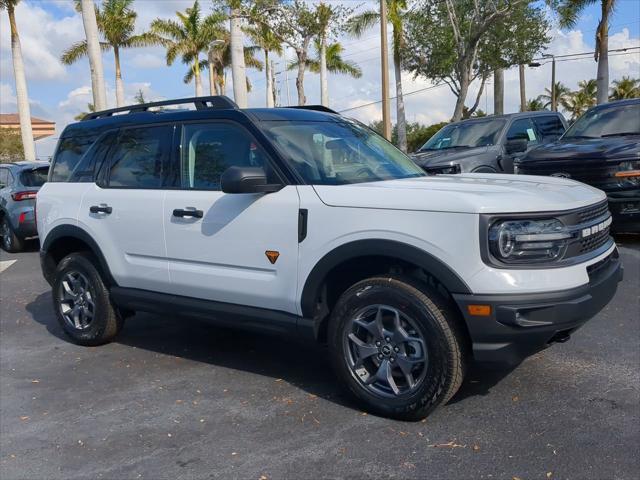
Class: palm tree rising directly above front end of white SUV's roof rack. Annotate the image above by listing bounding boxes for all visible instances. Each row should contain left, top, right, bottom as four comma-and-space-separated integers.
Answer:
151, 0, 223, 97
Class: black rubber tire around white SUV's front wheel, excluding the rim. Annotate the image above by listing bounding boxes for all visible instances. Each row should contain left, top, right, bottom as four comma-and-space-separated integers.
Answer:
329, 276, 466, 420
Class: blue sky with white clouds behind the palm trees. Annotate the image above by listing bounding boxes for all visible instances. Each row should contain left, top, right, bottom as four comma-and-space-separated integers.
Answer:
0, 0, 640, 159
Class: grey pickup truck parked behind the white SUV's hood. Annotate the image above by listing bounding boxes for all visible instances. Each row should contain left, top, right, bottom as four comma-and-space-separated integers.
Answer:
411, 112, 567, 174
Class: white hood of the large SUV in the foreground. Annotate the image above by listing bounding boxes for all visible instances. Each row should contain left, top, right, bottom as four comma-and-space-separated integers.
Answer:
313, 173, 606, 213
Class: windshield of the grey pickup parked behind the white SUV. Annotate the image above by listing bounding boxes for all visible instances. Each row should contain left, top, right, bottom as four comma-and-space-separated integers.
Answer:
419, 119, 505, 152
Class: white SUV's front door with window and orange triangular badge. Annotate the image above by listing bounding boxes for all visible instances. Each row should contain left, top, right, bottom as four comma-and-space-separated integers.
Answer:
164, 121, 299, 313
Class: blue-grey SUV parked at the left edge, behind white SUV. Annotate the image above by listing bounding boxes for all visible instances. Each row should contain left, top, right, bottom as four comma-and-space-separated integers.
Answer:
0, 162, 49, 252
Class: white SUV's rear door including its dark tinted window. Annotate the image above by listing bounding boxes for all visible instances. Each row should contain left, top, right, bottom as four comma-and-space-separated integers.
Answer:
78, 124, 174, 292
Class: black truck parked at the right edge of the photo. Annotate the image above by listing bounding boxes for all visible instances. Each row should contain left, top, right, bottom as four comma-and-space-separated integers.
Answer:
517, 99, 640, 232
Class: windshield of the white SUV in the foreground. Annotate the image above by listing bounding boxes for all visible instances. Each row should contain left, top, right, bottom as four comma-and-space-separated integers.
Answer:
261, 119, 425, 185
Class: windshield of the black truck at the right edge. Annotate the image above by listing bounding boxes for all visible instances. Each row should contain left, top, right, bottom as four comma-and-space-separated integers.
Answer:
562, 103, 640, 138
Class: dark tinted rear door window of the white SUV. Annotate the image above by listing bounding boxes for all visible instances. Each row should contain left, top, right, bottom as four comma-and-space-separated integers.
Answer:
108, 125, 173, 188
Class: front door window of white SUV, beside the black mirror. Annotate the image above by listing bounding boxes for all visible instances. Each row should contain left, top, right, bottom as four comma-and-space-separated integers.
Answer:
180, 122, 273, 190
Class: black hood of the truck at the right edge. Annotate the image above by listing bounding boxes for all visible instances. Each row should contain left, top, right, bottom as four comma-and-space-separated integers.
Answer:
518, 135, 640, 165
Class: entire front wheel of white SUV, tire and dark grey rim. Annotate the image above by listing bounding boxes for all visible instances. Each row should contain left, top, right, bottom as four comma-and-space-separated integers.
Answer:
329, 277, 465, 420
